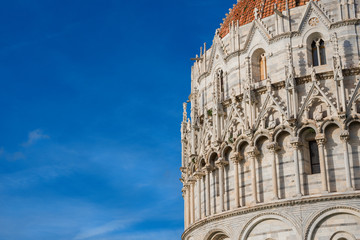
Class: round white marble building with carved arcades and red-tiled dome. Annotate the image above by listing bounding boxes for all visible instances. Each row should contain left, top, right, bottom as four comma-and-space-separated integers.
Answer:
180, 0, 360, 240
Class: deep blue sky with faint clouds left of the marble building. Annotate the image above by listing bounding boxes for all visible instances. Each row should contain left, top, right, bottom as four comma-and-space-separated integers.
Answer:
0, 0, 236, 240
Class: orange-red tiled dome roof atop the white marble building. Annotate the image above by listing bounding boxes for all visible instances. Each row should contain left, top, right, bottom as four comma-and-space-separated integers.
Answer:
220, 0, 309, 38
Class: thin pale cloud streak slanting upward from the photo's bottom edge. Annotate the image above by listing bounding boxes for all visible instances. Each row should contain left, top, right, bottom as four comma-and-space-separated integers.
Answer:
74, 218, 138, 240
